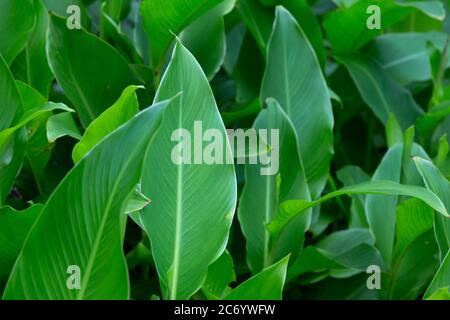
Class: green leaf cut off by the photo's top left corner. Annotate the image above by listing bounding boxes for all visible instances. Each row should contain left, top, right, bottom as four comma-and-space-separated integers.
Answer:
0, 0, 34, 64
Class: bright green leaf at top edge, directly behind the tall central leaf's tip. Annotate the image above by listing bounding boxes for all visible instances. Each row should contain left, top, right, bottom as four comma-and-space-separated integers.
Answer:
141, 0, 222, 72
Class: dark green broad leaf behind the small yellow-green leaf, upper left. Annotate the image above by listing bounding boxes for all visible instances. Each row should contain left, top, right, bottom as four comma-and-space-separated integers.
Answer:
47, 15, 139, 127
